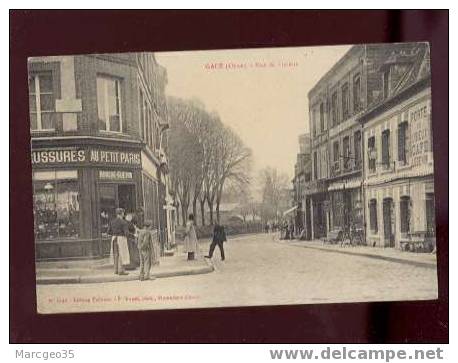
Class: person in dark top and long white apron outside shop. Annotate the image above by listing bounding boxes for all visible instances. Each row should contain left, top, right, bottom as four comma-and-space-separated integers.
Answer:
108, 208, 130, 275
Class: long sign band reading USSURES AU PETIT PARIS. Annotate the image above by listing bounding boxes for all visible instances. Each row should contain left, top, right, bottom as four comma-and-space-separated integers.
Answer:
31, 148, 141, 167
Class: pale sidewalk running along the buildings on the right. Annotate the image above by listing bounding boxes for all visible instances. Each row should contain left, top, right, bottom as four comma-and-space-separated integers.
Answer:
274, 236, 437, 269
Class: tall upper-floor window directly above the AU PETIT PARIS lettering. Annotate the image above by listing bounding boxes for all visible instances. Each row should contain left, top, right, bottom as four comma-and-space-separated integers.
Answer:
97, 76, 123, 132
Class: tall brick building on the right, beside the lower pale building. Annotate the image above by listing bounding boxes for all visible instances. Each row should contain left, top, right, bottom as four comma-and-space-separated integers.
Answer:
308, 43, 430, 243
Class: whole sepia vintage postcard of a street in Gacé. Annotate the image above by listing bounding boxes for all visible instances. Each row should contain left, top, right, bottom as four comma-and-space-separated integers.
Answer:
28, 43, 438, 313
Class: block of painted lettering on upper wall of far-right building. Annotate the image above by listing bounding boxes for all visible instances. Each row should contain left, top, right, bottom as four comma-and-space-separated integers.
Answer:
409, 103, 431, 166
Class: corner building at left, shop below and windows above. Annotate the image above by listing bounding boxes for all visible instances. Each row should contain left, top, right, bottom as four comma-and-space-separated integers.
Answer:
28, 53, 173, 260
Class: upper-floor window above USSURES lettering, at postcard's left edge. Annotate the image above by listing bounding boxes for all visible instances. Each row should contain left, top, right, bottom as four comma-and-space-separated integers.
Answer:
29, 72, 56, 130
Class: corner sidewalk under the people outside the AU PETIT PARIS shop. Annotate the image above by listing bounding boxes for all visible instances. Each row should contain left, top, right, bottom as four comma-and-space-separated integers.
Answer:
36, 246, 214, 285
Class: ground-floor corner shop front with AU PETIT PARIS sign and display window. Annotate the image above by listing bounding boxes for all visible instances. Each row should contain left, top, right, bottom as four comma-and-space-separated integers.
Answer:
32, 145, 143, 260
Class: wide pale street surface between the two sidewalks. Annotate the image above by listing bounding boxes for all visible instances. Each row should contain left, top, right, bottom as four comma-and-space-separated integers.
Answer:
37, 234, 437, 313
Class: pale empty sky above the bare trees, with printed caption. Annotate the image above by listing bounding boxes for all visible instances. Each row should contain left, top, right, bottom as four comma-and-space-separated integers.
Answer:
156, 46, 350, 179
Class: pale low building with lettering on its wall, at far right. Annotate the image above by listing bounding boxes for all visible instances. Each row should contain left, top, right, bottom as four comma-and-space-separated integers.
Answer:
360, 44, 435, 251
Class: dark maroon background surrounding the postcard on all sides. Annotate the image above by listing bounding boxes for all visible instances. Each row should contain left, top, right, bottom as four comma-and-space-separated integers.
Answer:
10, 10, 449, 343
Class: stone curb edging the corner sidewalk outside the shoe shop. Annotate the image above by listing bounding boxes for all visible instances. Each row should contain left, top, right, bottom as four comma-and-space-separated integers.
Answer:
37, 263, 215, 285
